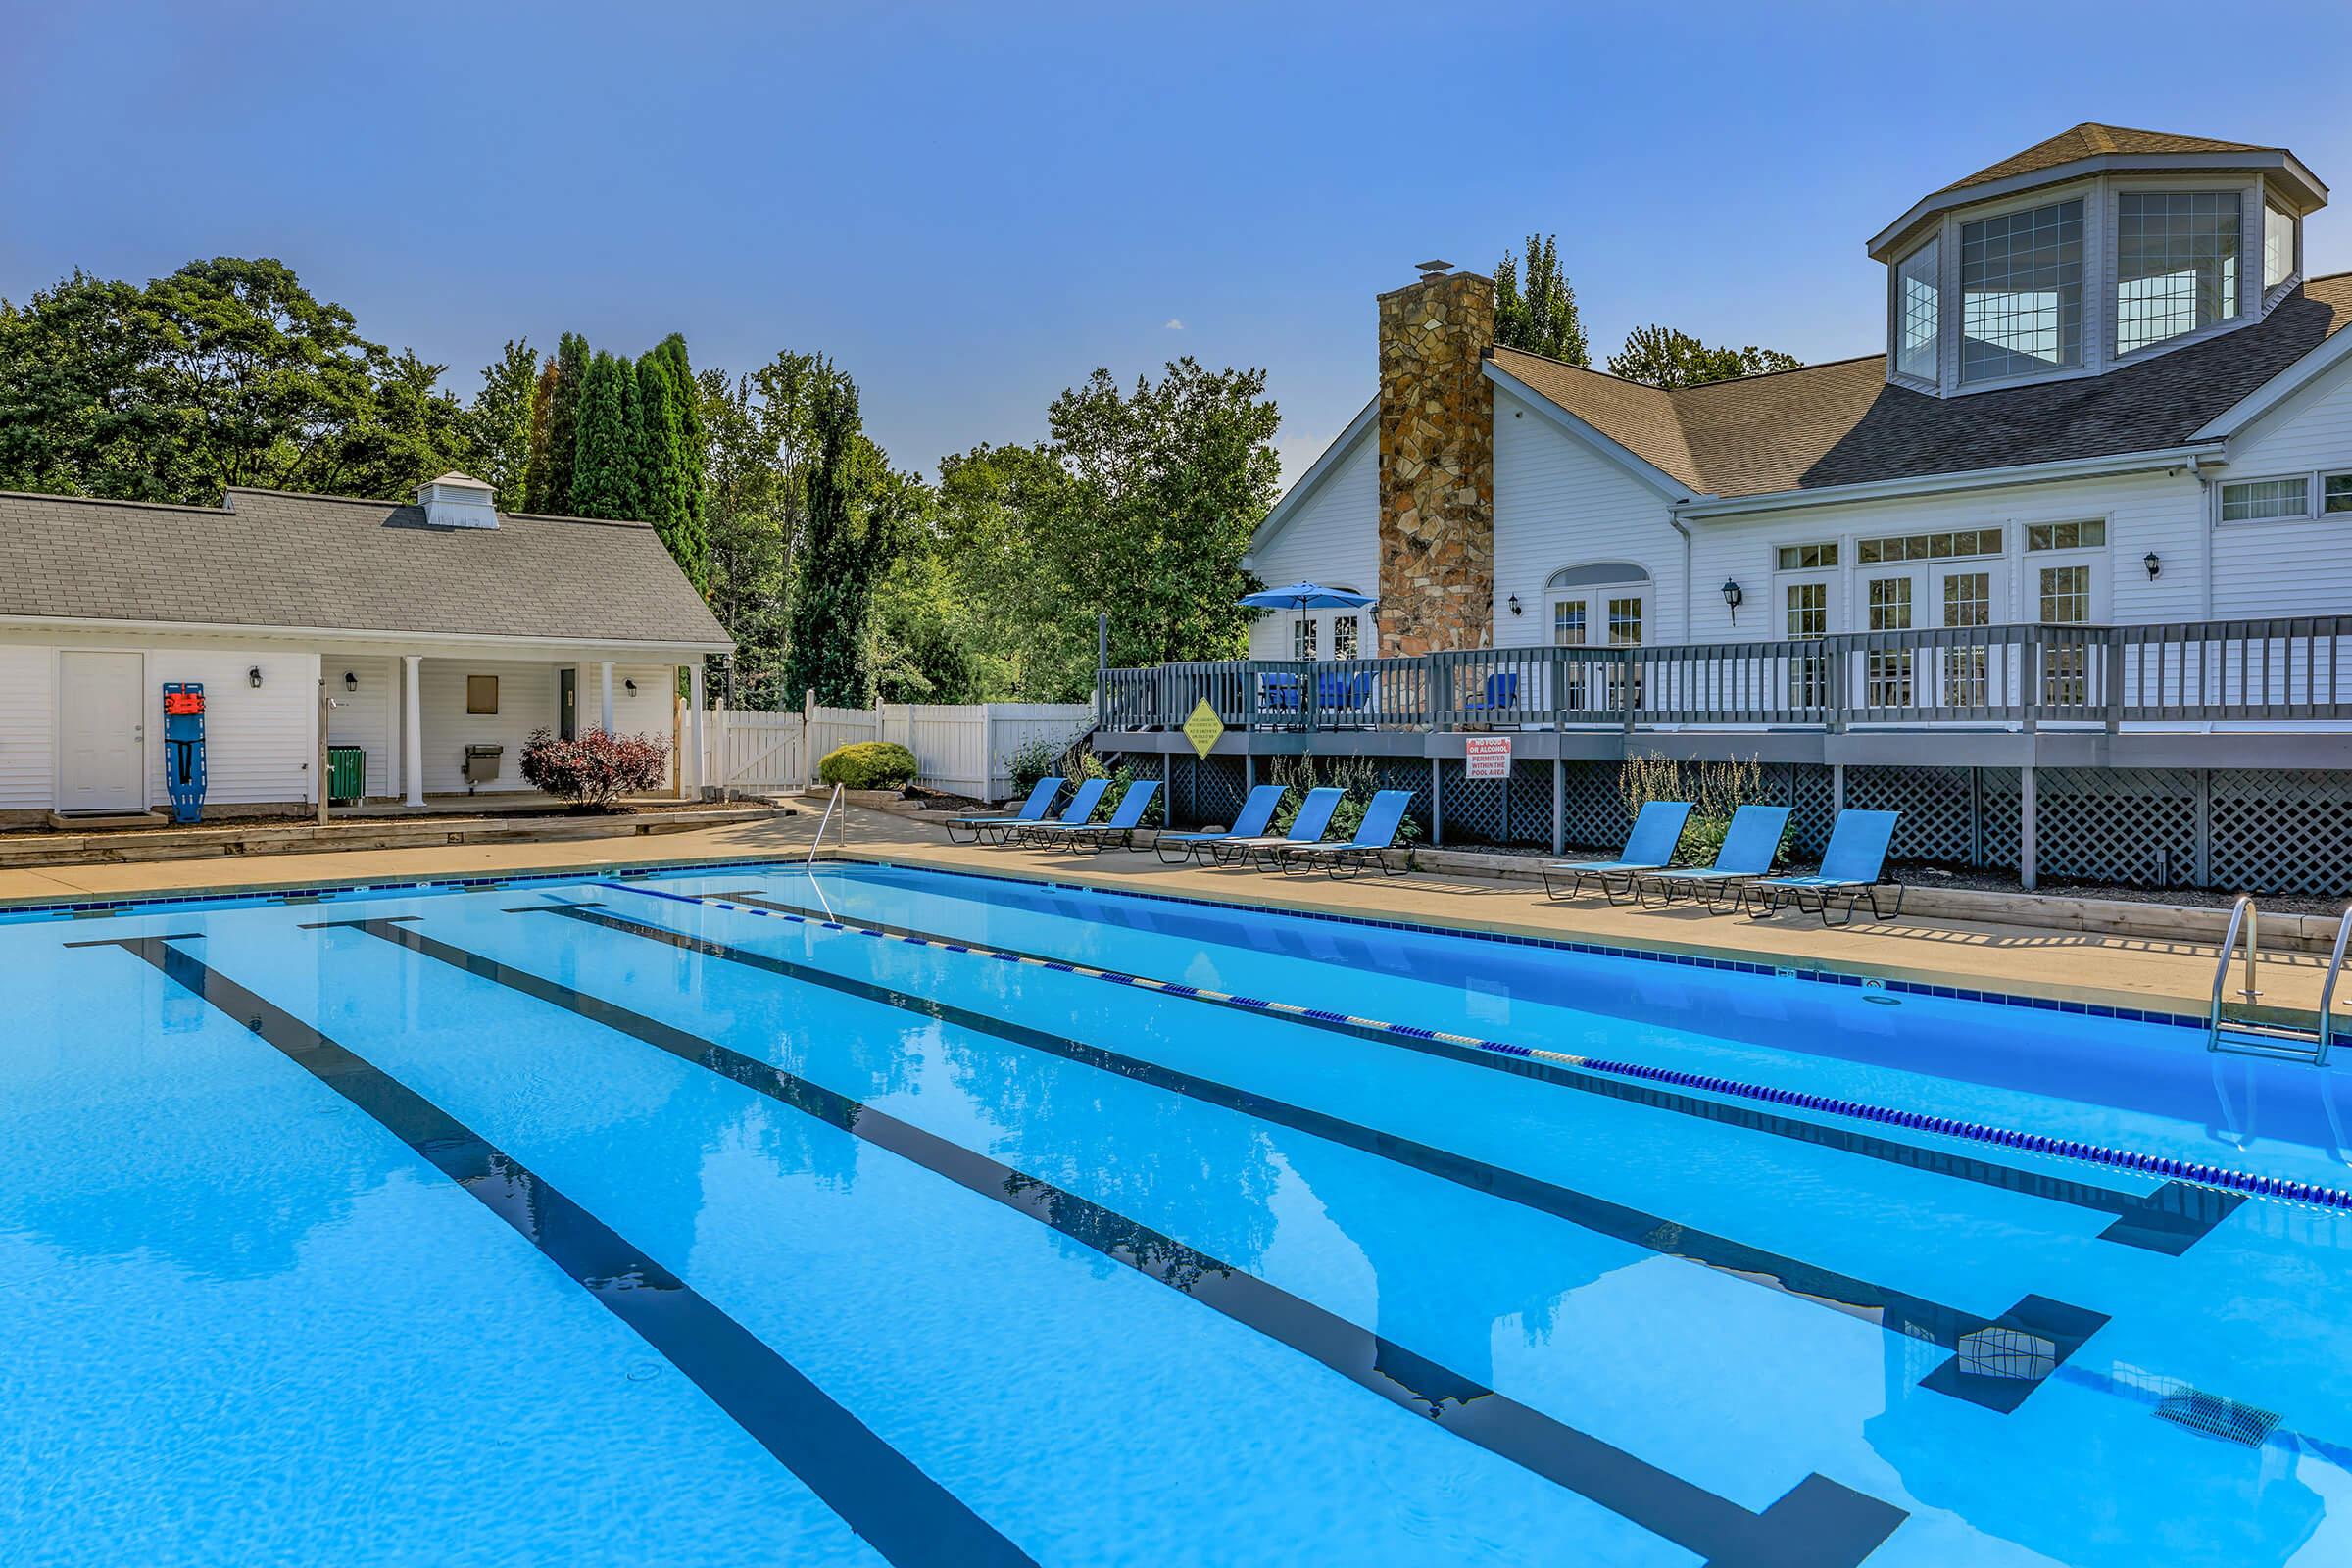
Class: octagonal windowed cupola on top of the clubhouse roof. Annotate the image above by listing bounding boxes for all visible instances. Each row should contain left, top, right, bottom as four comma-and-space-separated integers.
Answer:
1870, 120, 2328, 397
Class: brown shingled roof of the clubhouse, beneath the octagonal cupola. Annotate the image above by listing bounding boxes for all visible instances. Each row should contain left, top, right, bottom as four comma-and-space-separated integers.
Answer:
1494, 272, 2352, 499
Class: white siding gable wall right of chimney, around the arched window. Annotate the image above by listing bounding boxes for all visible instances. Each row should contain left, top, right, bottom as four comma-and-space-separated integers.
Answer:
1494, 390, 1682, 647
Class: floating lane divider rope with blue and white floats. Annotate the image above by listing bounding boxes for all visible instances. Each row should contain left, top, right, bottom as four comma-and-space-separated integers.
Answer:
598, 882, 2352, 1213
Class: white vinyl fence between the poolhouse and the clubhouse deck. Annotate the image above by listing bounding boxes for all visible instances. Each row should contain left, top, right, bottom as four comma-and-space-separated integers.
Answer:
704, 703, 1094, 800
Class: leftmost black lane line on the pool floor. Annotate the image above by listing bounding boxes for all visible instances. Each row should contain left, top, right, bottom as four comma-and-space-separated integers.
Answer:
106, 917, 1037, 1568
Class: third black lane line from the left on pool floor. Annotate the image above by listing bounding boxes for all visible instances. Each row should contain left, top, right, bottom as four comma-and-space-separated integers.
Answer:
513, 903, 2107, 1413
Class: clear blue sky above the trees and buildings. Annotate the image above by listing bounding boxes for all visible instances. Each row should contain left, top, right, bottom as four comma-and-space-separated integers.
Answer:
0, 0, 2352, 491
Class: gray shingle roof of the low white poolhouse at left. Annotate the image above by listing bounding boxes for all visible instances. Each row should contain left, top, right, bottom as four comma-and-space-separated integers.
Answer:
0, 489, 731, 649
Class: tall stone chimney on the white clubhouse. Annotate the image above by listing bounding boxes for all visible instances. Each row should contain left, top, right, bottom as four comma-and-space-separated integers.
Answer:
1378, 261, 1494, 654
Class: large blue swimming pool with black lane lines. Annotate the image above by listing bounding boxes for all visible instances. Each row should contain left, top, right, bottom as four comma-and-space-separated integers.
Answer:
0, 865, 2352, 1568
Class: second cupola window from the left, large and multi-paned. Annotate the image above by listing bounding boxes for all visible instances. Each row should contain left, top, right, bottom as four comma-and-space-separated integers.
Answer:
1959, 200, 2082, 381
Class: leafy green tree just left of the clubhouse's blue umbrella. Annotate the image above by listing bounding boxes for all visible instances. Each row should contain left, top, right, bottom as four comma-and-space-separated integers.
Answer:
1033, 358, 1282, 665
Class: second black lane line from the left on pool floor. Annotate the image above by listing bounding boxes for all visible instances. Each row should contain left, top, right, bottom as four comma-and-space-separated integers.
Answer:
331, 906, 1910, 1568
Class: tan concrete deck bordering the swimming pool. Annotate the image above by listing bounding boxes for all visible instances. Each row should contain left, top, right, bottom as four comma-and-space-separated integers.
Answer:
0, 808, 2324, 1015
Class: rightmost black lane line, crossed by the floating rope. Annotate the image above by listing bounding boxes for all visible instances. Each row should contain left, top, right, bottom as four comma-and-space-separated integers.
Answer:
696, 884, 2246, 1257
